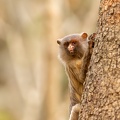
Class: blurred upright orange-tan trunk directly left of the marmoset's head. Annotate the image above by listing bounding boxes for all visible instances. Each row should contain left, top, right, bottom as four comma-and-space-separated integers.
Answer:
46, 0, 63, 120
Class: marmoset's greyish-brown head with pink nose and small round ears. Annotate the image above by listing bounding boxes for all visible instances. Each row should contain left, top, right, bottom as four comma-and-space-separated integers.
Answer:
57, 33, 88, 62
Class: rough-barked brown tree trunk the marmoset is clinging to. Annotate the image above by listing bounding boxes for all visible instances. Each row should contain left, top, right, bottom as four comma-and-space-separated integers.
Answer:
79, 0, 120, 120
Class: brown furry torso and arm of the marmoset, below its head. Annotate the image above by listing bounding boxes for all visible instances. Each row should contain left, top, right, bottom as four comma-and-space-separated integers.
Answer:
65, 45, 91, 111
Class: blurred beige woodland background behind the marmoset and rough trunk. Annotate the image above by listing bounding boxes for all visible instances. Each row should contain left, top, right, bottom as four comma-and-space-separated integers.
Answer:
0, 0, 99, 120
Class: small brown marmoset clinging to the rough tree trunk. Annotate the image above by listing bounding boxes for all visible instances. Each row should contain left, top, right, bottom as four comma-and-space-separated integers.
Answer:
57, 33, 93, 120
